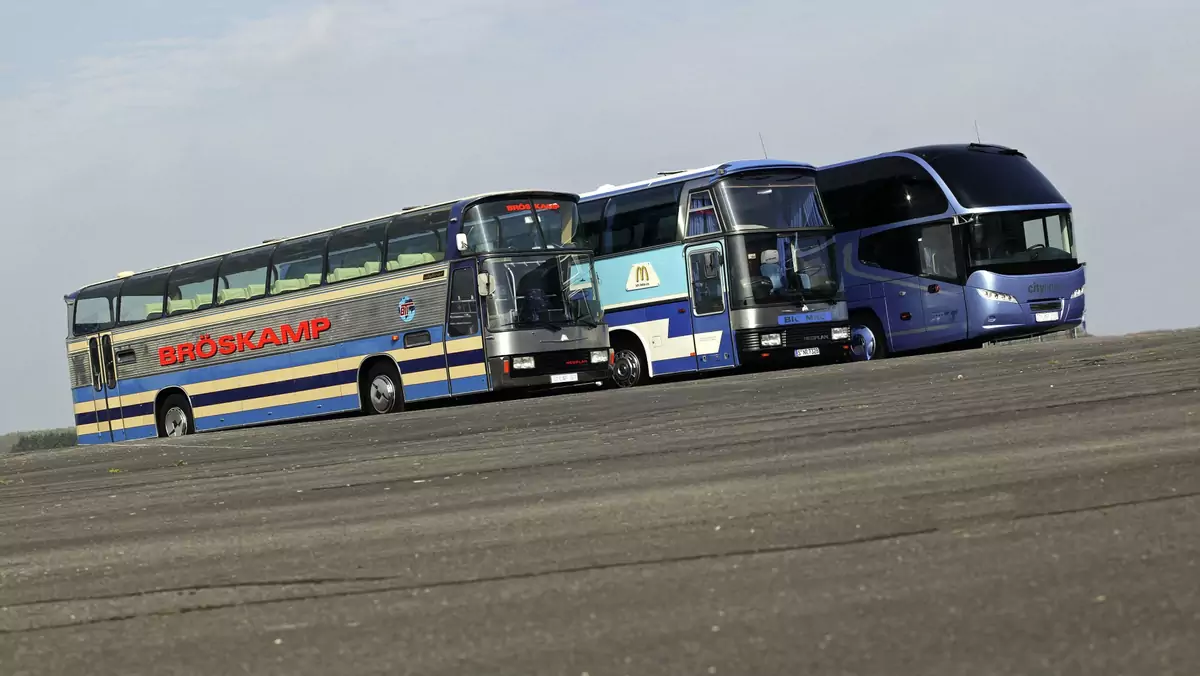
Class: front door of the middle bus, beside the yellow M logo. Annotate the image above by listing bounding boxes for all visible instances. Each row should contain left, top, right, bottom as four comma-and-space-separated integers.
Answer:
684, 243, 737, 371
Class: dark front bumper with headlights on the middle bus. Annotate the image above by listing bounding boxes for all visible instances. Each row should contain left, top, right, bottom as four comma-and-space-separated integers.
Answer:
737, 322, 851, 366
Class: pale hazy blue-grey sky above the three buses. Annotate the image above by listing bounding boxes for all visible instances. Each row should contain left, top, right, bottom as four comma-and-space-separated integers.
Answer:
0, 0, 1200, 432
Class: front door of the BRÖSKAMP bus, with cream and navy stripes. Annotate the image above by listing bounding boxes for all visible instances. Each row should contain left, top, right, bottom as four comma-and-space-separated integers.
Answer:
445, 259, 488, 395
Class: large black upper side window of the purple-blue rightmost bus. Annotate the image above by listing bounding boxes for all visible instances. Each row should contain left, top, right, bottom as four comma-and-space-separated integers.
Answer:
817, 157, 949, 231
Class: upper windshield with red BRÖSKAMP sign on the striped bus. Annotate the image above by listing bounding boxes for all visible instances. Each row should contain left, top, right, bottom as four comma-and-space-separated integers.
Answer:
462, 202, 577, 253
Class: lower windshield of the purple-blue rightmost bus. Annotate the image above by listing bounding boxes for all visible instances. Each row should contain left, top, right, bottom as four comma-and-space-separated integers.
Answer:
965, 211, 1076, 274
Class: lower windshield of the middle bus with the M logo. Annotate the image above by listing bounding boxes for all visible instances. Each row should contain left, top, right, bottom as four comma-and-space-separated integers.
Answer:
730, 232, 839, 306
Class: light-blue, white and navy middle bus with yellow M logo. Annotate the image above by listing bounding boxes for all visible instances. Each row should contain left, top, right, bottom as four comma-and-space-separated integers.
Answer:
564, 160, 851, 388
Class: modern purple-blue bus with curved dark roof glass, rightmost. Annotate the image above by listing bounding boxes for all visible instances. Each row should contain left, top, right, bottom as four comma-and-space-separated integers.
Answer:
817, 143, 1085, 360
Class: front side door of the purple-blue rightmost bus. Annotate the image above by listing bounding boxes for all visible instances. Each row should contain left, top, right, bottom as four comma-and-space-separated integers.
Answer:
917, 221, 967, 347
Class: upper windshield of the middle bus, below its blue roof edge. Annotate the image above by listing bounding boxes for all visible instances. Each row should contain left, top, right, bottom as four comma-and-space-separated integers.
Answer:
720, 174, 828, 231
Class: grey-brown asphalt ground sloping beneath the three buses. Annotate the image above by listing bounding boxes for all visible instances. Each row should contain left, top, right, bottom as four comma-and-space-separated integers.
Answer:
0, 331, 1200, 676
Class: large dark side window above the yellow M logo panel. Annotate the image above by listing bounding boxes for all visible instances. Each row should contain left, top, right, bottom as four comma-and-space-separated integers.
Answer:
600, 184, 683, 253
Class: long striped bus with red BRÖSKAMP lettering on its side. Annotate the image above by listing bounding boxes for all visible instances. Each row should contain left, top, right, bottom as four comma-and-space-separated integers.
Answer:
65, 191, 613, 444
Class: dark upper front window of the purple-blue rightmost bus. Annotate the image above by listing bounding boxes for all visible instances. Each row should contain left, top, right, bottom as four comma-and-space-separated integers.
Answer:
925, 150, 1067, 209
